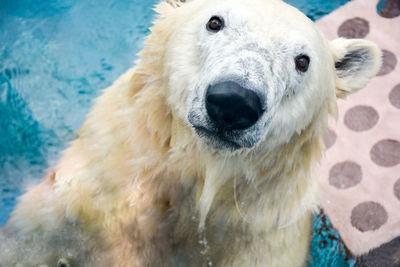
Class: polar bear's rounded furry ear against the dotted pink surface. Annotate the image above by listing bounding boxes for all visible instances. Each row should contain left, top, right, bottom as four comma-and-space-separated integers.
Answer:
331, 38, 382, 98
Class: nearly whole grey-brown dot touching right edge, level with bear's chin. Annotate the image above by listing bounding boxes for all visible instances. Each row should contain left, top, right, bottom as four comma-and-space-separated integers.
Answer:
370, 139, 400, 167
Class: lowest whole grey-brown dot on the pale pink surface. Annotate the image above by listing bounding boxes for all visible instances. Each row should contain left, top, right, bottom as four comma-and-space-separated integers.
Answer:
351, 201, 388, 232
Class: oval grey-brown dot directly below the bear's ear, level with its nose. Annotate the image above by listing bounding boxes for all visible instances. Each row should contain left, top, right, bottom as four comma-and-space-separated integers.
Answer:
344, 105, 379, 132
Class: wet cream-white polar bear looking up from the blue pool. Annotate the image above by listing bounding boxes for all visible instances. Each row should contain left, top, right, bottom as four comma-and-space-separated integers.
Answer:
0, 0, 381, 267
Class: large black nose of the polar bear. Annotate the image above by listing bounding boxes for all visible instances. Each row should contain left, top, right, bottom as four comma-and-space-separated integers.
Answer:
206, 82, 263, 130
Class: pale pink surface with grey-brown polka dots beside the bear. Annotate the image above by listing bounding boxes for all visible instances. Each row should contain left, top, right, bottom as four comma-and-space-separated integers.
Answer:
317, 0, 400, 267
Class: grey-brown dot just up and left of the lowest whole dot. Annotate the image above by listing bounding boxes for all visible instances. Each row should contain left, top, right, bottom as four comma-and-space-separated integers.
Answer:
329, 161, 362, 189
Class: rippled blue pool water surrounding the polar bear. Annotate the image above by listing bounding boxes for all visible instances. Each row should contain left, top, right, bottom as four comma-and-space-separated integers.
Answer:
0, 0, 352, 266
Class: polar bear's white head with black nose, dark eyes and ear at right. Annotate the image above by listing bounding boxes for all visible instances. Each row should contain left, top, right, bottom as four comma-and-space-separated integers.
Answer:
165, 0, 380, 151
